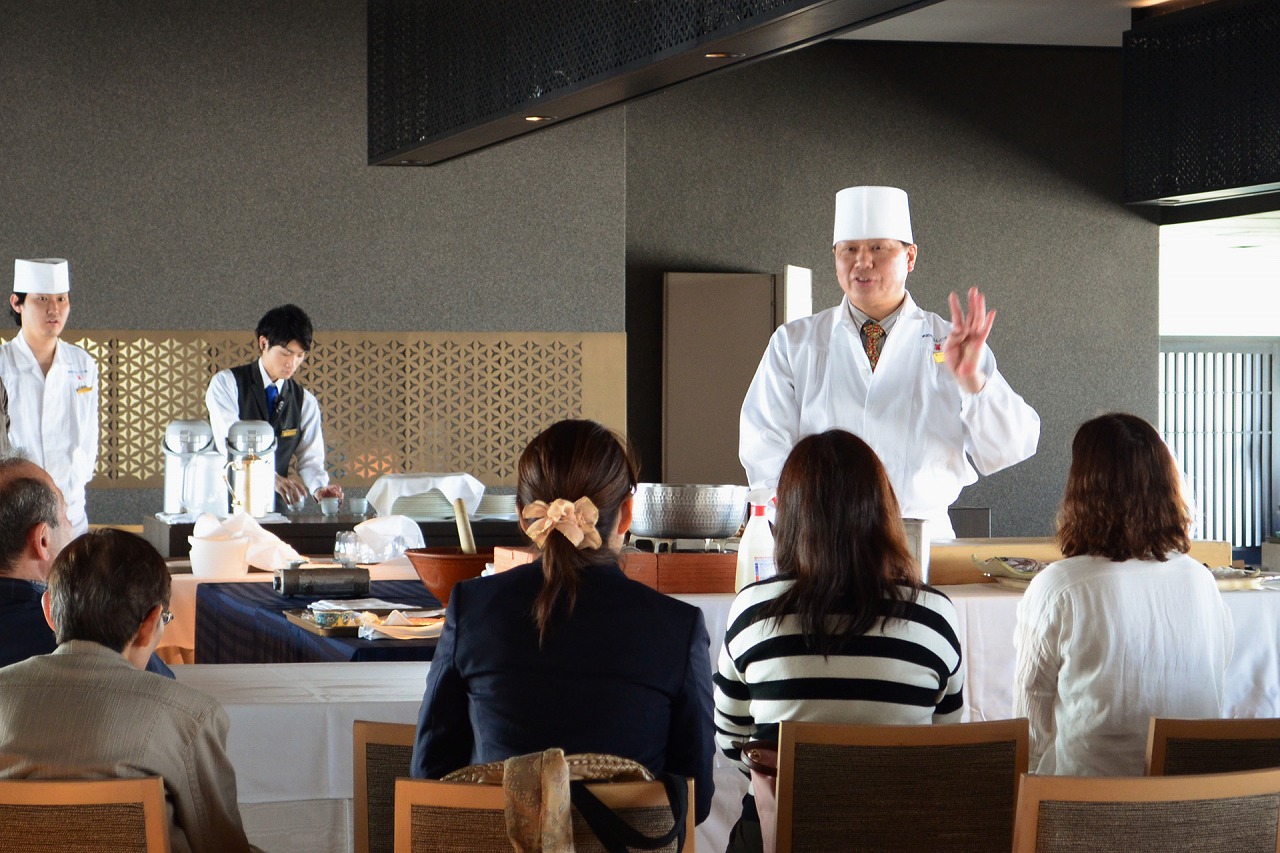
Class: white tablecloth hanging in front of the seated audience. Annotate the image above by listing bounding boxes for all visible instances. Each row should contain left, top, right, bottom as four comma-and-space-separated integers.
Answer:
170, 584, 1280, 853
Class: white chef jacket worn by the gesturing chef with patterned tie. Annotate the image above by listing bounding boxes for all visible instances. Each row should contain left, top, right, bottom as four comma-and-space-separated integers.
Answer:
739, 293, 1039, 538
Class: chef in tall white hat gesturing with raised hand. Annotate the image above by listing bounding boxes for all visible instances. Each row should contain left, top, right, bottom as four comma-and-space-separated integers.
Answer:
739, 187, 1039, 538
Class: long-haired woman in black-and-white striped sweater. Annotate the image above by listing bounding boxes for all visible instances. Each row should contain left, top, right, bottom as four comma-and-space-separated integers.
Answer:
714, 429, 964, 852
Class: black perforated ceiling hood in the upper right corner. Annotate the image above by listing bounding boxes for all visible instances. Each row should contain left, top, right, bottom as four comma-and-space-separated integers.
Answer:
1124, 0, 1280, 210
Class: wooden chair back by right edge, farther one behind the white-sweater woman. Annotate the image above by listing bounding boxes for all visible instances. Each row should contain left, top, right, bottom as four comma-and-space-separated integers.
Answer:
1147, 717, 1280, 776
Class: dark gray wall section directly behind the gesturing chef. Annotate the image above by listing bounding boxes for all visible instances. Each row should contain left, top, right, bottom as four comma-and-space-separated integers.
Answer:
627, 42, 1158, 535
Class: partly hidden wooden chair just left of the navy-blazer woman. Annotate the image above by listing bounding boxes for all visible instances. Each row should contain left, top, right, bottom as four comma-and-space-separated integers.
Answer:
351, 720, 417, 853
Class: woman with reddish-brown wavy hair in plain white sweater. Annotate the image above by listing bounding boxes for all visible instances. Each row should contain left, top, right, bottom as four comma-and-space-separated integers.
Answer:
1014, 414, 1233, 776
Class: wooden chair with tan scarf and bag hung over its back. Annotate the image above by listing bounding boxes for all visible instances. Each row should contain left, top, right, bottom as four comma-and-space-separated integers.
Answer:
396, 779, 694, 853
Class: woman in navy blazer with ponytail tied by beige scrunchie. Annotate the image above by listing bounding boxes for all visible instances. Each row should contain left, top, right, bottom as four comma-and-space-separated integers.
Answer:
412, 420, 714, 821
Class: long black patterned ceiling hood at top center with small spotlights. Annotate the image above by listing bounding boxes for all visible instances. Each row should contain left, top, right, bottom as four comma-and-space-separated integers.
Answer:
367, 0, 937, 165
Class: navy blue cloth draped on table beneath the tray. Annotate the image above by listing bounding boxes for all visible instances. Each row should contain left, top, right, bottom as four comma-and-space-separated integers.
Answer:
196, 580, 440, 663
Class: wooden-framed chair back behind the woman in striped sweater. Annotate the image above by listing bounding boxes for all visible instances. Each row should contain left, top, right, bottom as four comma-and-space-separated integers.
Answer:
765, 719, 1028, 853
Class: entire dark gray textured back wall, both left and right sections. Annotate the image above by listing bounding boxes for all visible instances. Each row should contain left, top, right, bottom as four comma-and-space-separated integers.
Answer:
0, 0, 1157, 534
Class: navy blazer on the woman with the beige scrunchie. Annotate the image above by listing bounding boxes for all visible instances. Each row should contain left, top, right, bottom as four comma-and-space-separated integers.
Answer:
412, 561, 716, 821
